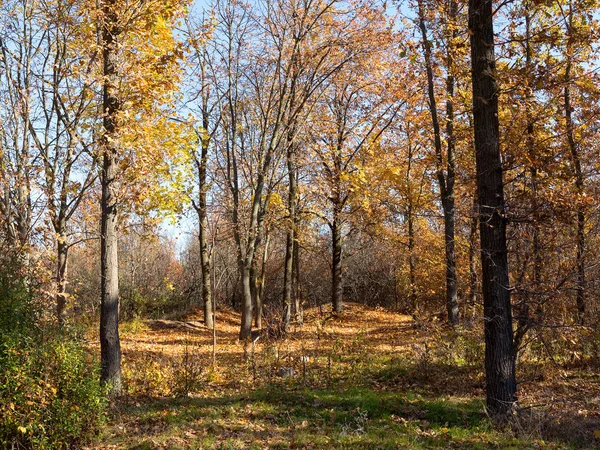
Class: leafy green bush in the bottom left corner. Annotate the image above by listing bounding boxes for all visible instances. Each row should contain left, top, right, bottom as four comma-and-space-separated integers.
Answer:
0, 262, 106, 449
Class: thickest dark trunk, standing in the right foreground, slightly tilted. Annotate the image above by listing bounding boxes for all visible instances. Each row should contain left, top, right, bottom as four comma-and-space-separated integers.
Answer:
469, 0, 517, 420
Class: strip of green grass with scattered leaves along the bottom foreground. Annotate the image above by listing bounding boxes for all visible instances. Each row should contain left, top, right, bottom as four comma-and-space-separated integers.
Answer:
103, 383, 567, 449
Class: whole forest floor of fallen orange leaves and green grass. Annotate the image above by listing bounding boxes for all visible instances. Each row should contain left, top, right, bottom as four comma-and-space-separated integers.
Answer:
93, 304, 600, 449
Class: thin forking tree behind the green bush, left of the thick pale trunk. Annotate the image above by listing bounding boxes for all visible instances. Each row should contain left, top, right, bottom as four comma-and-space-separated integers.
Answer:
27, 3, 98, 324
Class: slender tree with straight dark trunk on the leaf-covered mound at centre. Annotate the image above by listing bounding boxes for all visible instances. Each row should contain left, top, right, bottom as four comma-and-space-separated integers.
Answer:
310, 36, 404, 314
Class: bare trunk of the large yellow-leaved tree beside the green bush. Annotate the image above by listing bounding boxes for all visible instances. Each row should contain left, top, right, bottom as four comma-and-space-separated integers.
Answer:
100, 0, 121, 395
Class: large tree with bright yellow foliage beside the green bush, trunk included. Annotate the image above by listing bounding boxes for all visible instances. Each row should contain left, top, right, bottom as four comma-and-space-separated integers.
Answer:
98, 0, 185, 394
